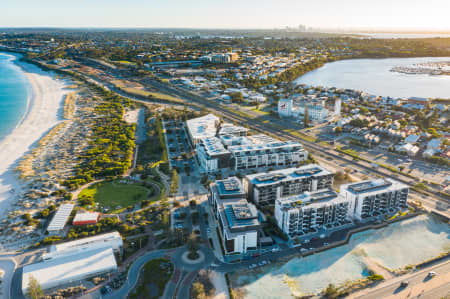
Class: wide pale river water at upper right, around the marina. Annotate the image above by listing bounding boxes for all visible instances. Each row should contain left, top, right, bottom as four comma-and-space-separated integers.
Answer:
295, 57, 450, 99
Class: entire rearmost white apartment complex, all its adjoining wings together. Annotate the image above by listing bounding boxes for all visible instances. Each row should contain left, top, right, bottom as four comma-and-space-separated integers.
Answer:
186, 114, 308, 173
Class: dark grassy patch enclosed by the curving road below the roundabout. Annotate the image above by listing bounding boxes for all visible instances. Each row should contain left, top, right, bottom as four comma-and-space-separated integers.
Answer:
129, 259, 173, 299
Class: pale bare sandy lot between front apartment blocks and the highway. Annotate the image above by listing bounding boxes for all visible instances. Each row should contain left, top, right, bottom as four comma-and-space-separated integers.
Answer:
232, 215, 450, 299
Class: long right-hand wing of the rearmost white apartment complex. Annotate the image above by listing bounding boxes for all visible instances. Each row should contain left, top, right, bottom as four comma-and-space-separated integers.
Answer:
228, 134, 308, 171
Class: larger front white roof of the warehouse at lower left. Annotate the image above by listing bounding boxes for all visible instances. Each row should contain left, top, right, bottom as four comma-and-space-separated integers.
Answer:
22, 248, 117, 294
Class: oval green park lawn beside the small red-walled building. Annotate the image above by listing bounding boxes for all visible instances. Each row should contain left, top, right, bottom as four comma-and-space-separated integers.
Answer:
79, 180, 152, 212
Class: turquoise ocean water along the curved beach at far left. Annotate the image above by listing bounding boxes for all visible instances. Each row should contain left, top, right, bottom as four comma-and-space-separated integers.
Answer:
0, 53, 31, 141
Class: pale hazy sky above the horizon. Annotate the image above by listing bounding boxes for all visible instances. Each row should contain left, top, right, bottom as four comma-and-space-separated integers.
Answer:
0, 0, 450, 29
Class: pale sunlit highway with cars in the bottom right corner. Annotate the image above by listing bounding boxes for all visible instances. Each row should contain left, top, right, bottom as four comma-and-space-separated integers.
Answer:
349, 260, 450, 299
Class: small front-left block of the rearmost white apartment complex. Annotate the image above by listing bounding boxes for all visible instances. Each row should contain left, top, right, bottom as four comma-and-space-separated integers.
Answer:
196, 137, 231, 173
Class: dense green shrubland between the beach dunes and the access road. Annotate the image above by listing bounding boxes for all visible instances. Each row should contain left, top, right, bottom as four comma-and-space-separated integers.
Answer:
63, 96, 135, 190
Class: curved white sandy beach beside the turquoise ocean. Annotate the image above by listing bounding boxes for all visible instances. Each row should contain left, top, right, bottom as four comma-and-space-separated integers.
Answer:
0, 59, 67, 223
